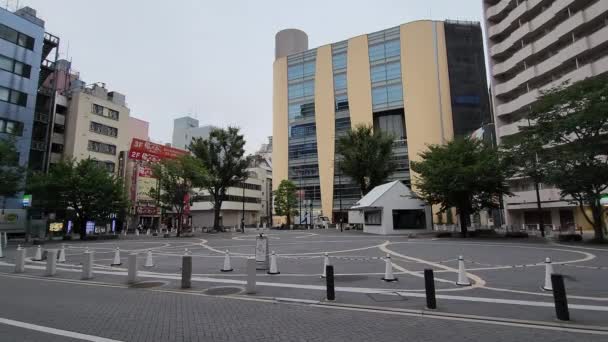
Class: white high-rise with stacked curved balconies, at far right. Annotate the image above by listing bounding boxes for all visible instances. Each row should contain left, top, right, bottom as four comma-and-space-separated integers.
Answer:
483, 0, 608, 227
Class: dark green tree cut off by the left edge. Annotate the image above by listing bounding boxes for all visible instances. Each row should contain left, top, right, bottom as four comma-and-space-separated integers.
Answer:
0, 139, 25, 213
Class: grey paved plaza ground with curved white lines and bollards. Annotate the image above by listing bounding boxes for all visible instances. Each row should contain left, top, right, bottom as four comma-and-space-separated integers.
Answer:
0, 229, 608, 341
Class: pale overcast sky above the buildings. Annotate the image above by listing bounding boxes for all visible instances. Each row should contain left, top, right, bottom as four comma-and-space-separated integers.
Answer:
15, 0, 482, 152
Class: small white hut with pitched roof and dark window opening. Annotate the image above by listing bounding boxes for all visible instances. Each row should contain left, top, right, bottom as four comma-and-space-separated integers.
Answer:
349, 181, 433, 235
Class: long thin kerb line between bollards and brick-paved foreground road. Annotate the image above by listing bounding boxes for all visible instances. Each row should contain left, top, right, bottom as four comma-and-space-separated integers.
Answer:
2, 274, 608, 334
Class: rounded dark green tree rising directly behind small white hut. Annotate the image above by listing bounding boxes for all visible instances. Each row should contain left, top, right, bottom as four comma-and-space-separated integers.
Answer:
336, 125, 395, 196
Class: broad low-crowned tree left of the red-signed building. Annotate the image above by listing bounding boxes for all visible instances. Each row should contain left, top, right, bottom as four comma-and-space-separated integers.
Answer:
28, 158, 128, 239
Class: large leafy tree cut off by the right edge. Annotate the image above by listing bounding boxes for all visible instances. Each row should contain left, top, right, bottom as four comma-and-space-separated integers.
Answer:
518, 76, 608, 242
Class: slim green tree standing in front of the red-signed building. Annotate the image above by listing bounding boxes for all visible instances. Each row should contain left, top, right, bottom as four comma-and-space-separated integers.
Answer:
150, 155, 207, 236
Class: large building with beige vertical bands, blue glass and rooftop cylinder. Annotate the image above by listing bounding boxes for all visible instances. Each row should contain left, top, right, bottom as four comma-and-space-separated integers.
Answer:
272, 20, 492, 220
